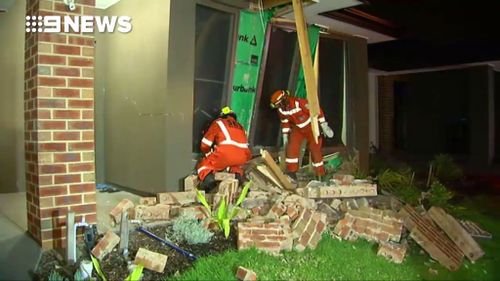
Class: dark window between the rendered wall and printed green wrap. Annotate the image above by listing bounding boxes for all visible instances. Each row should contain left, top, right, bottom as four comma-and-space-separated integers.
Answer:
192, 5, 235, 152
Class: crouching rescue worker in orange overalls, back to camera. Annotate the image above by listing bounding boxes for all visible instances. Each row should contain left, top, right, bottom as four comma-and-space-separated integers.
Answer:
196, 106, 252, 190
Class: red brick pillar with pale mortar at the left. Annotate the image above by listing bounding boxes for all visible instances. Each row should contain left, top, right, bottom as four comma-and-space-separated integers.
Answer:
24, 0, 96, 249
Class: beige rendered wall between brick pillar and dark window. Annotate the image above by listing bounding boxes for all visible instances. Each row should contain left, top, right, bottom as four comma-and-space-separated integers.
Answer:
96, 0, 195, 192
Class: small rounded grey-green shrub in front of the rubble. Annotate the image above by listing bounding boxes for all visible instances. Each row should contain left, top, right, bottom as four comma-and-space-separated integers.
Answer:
172, 213, 214, 244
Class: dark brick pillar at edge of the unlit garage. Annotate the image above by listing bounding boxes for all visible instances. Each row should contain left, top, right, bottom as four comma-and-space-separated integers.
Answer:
378, 76, 395, 154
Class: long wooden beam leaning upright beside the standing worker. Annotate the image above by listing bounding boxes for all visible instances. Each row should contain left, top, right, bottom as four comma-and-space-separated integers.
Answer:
292, 0, 319, 140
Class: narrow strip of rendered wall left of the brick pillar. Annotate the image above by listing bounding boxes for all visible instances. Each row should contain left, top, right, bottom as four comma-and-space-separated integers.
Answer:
0, 0, 26, 193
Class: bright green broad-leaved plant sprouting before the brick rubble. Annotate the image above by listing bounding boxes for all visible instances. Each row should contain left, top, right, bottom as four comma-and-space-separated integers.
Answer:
197, 181, 252, 238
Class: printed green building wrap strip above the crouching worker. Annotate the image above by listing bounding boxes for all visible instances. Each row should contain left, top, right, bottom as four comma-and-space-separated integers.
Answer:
231, 11, 272, 132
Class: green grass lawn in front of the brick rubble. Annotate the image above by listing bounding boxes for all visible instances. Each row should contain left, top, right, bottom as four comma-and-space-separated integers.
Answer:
167, 197, 500, 280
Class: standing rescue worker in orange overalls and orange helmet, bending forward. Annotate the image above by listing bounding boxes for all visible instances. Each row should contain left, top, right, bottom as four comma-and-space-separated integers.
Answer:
271, 90, 333, 180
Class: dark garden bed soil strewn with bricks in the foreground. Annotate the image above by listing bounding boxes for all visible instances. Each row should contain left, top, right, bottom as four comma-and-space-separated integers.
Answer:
35, 222, 237, 280
